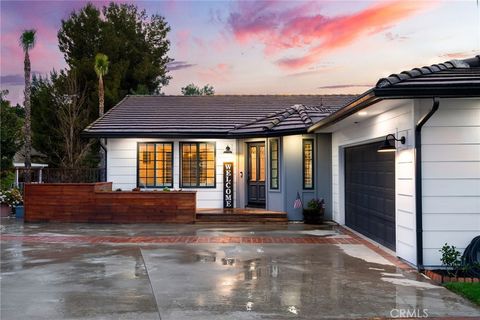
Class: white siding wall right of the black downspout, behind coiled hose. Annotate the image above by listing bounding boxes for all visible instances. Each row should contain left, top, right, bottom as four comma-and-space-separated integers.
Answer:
415, 98, 480, 266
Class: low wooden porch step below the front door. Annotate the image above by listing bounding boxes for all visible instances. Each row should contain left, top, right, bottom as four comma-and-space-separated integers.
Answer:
195, 209, 288, 223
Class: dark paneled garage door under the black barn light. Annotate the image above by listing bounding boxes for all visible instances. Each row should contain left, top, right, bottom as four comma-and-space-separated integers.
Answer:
345, 142, 395, 250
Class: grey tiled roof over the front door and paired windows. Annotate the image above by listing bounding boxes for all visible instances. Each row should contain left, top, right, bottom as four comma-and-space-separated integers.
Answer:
83, 95, 355, 137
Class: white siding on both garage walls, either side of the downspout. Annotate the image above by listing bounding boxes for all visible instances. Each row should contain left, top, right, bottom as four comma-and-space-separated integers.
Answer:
320, 98, 480, 267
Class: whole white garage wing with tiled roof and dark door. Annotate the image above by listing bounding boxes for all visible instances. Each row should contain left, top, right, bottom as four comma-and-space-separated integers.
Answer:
309, 56, 480, 267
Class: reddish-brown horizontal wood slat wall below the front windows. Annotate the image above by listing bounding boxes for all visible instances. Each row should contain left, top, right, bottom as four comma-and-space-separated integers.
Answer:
24, 182, 196, 223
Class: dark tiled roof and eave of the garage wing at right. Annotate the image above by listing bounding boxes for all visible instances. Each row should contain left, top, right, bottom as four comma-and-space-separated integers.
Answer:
308, 55, 480, 132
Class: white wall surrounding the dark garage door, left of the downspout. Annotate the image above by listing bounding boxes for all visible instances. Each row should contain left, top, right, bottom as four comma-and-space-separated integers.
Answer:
332, 100, 416, 264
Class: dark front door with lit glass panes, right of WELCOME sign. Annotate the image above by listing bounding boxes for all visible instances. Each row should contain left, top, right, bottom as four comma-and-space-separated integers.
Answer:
247, 142, 265, 208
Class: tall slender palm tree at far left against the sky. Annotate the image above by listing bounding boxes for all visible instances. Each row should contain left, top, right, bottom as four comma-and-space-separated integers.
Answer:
20, 29, 37, 183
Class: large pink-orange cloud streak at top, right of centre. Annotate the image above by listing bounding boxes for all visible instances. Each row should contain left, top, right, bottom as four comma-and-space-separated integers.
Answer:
228, 0, 432, 69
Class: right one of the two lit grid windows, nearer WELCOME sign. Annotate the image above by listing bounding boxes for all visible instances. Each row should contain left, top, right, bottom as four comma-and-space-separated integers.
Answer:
180, 142, 215, 188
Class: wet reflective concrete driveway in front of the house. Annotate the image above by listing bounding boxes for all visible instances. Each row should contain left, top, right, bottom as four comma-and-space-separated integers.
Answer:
0, 219, 480, 320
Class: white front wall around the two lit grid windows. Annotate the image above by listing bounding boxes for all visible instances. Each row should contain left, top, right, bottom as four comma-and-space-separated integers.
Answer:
107, 138, 239, 208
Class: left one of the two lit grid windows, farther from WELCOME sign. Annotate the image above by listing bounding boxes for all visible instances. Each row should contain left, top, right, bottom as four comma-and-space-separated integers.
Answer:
137, 142, 173, 188
